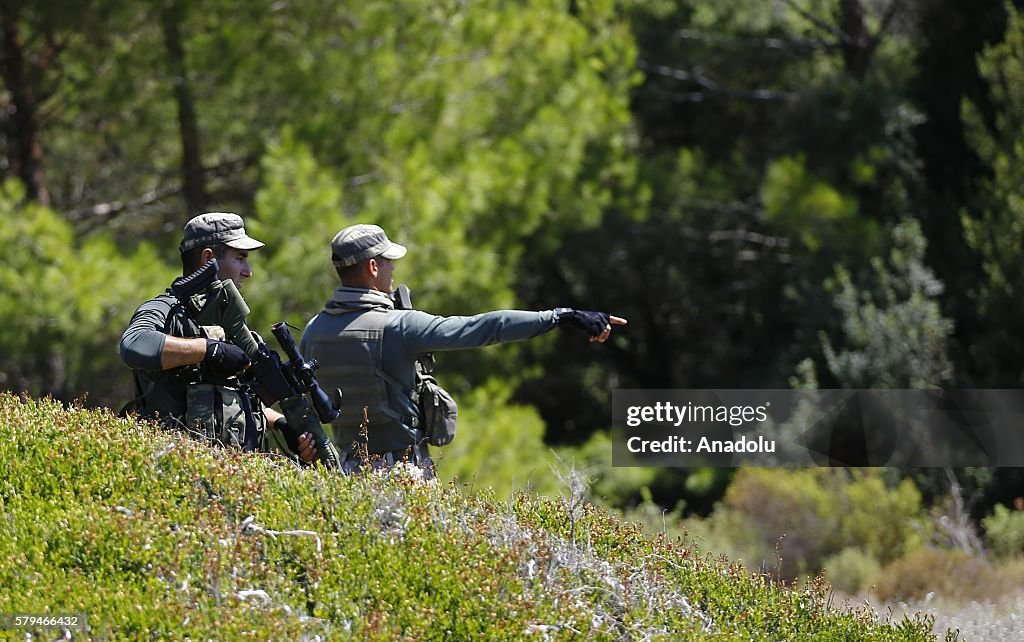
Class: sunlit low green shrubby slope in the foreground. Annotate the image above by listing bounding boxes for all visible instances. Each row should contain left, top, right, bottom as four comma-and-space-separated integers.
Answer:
0, 394, 946, 642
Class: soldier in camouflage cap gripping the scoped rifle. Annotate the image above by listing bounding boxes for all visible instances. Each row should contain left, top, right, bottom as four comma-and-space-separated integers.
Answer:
120, 212, 315, 462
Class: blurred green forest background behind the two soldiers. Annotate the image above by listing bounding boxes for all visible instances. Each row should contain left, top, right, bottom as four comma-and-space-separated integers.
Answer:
0, 0, 1024, 591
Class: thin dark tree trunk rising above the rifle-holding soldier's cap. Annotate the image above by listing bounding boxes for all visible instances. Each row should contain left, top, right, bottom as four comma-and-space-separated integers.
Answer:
162, 0, 209, 215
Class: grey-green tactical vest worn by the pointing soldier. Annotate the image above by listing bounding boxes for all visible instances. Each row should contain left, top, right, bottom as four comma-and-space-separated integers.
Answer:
309, 308, 418, 453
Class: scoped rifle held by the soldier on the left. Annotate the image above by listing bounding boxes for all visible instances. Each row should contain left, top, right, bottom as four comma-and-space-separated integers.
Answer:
171, 259, 341, 469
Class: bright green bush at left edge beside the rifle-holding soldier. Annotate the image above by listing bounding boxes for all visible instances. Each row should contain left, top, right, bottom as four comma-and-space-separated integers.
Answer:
0, 181, 172, 405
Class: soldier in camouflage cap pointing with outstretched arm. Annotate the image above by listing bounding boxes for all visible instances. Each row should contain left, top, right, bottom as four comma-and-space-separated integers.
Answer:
301, 224, 626, 476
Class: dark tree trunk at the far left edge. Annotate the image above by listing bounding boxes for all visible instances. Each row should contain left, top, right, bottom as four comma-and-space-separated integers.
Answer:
0, 3, 50, 205
